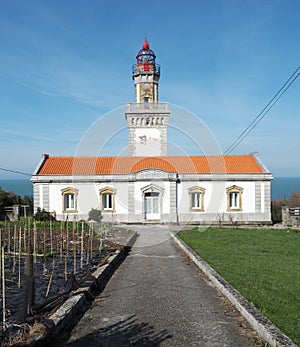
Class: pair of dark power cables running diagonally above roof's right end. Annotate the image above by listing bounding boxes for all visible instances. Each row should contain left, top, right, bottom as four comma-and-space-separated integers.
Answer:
223, 66, 300, 155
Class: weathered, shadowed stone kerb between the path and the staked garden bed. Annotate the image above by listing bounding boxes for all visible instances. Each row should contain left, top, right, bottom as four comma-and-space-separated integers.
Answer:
28, 231, 138, 347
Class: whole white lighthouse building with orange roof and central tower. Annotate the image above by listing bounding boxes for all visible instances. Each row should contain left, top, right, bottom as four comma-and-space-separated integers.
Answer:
31, 42, 272, 224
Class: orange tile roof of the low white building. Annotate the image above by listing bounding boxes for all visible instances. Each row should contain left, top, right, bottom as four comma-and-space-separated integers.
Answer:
37, 155, 264, 175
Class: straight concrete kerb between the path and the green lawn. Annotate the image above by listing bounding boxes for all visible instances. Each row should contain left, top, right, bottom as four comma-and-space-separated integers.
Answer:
170, 232, 298, 347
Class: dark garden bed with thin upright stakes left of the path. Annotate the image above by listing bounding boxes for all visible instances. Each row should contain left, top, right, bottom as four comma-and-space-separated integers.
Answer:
0, 230, 134, 346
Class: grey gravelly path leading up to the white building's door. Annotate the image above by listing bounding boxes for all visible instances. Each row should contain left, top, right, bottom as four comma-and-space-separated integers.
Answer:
64, 226, 255, 347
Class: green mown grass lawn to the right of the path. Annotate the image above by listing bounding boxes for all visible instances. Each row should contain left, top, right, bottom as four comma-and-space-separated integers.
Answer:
178, 228, 300, 345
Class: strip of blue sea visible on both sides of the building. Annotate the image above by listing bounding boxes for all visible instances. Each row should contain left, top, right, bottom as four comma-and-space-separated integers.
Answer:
0, 177, 300, 200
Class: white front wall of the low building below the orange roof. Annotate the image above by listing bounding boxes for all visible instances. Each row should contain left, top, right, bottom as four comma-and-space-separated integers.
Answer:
35, 170, 270, 222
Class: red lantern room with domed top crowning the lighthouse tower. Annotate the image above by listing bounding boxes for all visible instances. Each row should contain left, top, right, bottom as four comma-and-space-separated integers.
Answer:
132, 38, 160, 75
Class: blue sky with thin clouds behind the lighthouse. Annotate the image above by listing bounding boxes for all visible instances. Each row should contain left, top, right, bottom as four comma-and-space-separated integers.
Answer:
0, 0, 300, 178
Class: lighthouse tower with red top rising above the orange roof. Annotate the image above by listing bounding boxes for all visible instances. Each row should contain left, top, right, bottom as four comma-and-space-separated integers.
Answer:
125, 39, 170, 156
